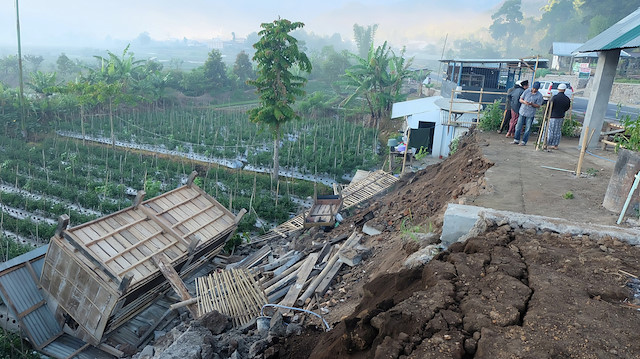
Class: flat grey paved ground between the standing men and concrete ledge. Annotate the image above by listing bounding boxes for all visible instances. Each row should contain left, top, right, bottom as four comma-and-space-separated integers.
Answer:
467, 132, 619, 225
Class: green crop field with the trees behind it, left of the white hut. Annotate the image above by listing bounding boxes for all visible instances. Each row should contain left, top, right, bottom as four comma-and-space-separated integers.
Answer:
0, 20, 418, 266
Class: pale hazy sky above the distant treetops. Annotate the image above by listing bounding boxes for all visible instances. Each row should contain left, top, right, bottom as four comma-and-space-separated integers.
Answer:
0, 0, 546, 47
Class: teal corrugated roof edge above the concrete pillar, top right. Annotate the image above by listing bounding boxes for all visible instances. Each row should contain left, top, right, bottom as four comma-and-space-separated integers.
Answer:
574, 8, 640, 52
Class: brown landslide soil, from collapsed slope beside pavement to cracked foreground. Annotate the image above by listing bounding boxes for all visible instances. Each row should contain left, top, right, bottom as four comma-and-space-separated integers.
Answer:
270, 131, 640, 358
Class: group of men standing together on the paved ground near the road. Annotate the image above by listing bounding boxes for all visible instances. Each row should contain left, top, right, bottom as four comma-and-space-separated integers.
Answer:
498, 80, 571, 149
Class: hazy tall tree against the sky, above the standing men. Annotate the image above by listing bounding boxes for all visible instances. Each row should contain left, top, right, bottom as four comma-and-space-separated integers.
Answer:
489, 0, 524, 54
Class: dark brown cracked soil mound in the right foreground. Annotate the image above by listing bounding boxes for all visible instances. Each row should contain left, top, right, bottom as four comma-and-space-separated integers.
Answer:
289, 225, 640, 358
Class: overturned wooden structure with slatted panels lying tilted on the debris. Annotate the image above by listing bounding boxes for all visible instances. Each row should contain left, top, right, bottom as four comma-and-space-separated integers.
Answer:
29, 173, 244, 352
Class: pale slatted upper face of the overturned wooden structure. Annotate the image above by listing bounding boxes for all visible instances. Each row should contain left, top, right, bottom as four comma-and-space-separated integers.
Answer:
59, 186, 235, 284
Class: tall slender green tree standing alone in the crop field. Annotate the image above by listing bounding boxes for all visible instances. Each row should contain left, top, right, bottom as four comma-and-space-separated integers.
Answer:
249, 19, 312, 180
